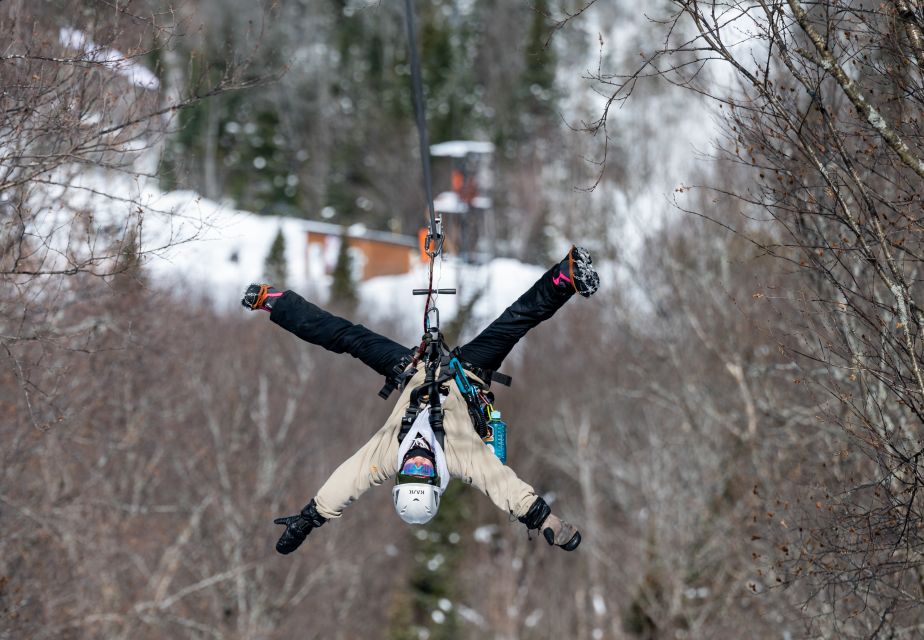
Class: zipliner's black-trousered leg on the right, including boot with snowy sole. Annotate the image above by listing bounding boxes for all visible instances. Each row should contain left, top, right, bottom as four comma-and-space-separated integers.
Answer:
459, 247, 599, 371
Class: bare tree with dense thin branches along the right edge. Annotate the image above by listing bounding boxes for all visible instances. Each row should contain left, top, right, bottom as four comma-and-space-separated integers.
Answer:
576, 0, 924, 637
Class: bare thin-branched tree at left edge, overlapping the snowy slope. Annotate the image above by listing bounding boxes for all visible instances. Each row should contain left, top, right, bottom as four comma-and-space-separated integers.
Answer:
0, 2, 270, 429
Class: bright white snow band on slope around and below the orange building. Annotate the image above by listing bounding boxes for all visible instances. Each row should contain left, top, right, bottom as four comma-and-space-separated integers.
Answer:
30, 156, 547, 336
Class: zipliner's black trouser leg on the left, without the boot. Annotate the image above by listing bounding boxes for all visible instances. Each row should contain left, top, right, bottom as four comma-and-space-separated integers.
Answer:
270, 291, 412, 377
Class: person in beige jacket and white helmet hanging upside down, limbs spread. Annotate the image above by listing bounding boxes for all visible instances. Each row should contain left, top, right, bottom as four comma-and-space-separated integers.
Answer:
241, 247, 599, 554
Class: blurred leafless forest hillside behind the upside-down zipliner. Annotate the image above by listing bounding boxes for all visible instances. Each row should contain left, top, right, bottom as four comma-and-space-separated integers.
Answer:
0, 0, 924, 640
